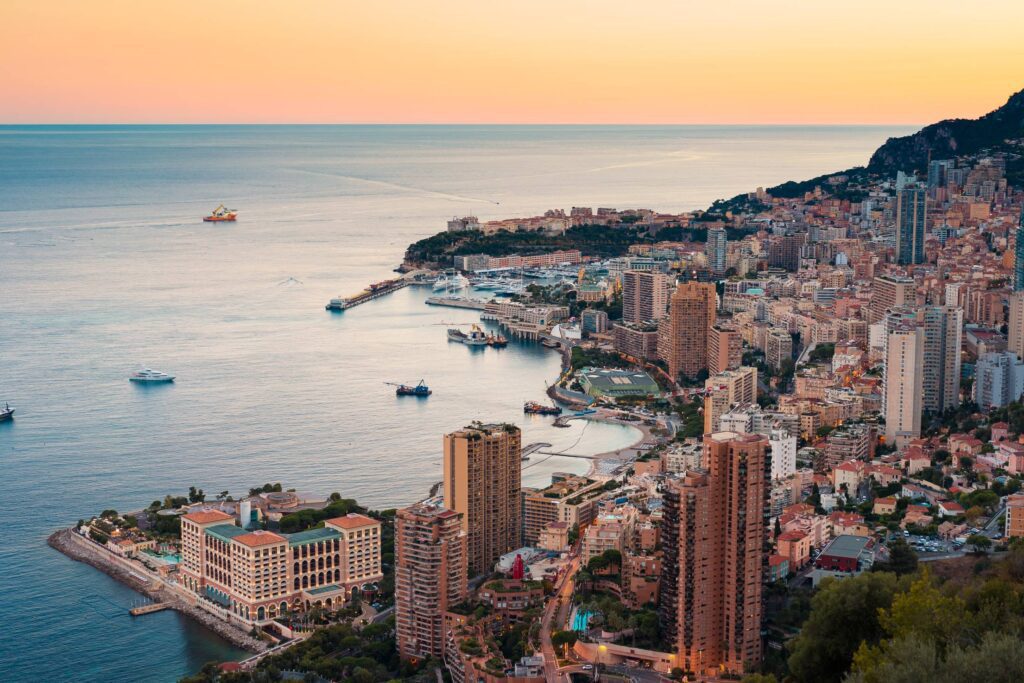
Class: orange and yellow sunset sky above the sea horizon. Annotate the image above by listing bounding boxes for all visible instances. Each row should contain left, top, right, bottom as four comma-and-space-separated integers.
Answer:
0, 0, 1024, 124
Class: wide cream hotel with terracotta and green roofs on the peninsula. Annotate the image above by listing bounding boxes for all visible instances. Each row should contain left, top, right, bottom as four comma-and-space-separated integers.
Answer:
178, 510, 384, 623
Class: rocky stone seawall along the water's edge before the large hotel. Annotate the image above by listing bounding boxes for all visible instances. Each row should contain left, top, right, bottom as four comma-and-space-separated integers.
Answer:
46, 528, 268, 652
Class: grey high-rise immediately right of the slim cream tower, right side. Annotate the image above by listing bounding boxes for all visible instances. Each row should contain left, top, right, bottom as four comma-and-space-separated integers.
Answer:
918, 306, 964, 413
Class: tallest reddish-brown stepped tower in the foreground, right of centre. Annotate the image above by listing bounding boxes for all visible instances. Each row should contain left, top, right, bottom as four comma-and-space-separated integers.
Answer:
659, 432, 771, 673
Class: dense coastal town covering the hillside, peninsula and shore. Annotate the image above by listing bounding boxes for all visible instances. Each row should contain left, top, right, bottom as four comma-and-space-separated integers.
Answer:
50, 94, 1024, 683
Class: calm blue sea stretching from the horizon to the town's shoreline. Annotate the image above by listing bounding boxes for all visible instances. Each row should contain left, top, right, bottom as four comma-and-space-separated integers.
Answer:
0, 126, 907, 682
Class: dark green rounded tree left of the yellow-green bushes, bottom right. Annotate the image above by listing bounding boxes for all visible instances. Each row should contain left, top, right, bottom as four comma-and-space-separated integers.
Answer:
788, 572, 899, 683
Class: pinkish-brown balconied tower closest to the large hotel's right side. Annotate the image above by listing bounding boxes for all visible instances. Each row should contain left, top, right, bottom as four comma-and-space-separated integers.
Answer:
394, 503, 467, 659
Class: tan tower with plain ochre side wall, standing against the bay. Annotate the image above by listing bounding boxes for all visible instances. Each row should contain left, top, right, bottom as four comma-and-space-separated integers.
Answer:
443, 423, 522, 572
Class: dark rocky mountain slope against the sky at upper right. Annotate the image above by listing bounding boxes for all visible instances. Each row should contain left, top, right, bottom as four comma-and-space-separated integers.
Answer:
867, 90, 1024, 174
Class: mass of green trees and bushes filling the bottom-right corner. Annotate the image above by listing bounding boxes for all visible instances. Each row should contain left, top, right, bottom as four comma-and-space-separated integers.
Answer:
782, 543, 1024, 683
